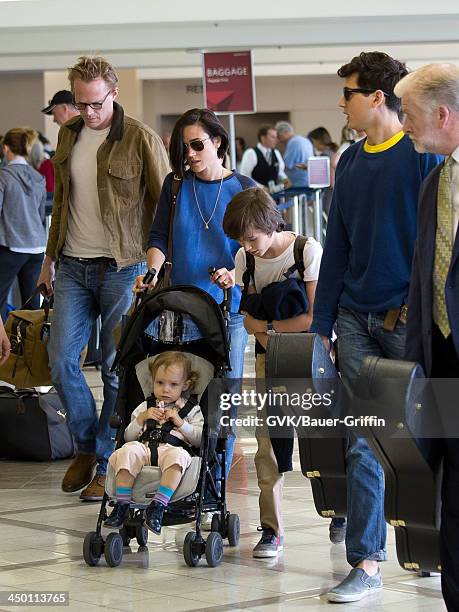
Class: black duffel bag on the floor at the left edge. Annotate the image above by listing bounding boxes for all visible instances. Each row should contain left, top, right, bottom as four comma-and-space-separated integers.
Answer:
0, 387, 74, 461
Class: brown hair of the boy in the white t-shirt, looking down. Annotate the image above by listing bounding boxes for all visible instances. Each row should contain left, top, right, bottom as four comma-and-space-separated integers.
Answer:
223, 187, 285, 240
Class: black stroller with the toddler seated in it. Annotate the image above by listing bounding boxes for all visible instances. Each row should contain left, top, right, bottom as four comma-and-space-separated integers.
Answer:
83, 286, 240, 567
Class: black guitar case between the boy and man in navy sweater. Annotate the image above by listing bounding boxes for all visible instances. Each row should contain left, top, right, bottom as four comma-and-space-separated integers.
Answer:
266, 333, 347, 517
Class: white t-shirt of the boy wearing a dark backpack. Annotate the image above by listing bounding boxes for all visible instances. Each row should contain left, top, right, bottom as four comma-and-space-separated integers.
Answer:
235, 232, 322, 293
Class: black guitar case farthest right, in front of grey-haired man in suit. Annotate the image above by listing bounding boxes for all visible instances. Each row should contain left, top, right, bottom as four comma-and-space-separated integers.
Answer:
352, 357, 442, 572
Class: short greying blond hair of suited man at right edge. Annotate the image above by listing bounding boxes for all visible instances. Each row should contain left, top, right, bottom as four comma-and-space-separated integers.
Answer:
394, 63, 459, 114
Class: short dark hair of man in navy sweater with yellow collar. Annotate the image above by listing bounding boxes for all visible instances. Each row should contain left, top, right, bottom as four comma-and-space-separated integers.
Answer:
338, 51, 408, 113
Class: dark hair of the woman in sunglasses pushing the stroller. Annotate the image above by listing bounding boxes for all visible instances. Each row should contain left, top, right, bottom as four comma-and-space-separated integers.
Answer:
169, 108, 229, 178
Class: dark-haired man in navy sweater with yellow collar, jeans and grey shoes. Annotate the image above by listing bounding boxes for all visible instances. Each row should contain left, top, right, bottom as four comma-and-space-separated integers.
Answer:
311, 52, 441, 602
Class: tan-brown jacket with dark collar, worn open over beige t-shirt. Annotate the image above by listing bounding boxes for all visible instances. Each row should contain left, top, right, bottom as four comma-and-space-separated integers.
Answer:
46, 102, 169, 267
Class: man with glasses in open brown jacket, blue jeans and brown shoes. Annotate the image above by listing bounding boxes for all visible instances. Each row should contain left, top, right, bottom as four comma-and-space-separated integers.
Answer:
38, 57, 169, 501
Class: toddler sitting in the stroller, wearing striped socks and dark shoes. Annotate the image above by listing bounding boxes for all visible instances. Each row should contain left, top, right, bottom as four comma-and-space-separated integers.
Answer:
104, 351, 204, 534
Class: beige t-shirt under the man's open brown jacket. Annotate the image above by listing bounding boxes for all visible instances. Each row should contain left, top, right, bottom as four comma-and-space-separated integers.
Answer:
63, 126, 113, 258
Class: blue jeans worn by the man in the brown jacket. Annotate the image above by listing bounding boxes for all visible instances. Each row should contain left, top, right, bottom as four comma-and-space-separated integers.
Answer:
48, 257, 143, 474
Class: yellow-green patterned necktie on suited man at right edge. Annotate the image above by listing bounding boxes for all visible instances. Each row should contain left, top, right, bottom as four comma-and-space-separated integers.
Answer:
433, 157, 453, 338
